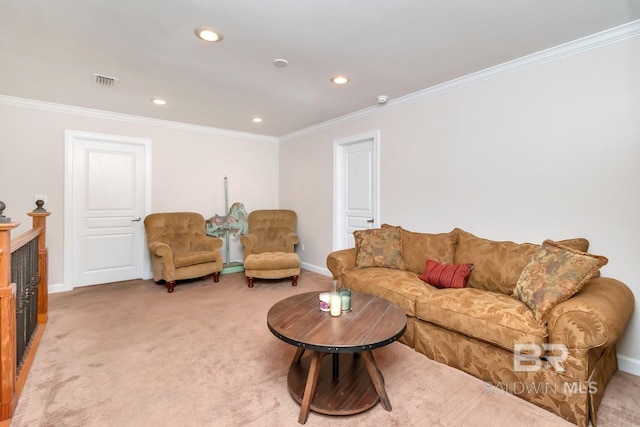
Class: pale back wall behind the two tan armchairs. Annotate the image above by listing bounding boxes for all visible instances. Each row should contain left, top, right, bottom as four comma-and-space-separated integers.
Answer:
0, 98, 278, 289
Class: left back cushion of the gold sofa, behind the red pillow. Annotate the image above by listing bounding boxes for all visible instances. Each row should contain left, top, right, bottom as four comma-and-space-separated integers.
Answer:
382, 224, 458, 274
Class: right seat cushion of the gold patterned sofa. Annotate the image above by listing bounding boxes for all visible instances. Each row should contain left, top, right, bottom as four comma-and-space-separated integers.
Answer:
416, 288, 548, 351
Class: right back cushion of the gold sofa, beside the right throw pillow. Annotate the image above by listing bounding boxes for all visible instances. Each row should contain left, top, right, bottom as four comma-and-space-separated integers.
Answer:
454, 228, 589, 295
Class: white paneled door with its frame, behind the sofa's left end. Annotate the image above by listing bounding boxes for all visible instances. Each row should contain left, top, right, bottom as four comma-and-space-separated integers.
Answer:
334, 132, 379, 250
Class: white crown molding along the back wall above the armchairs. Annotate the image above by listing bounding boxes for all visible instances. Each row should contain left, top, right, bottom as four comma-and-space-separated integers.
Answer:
0, 95, 279, 143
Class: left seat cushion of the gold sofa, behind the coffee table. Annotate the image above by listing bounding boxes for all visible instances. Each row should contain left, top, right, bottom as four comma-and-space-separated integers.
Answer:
341, 267, 428, 316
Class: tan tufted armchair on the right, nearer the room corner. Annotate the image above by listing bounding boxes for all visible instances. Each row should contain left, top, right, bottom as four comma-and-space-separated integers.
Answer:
240, 209, 300, 288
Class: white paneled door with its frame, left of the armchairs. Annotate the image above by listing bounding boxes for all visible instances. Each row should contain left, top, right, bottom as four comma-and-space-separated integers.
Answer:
65, 131, 150, 287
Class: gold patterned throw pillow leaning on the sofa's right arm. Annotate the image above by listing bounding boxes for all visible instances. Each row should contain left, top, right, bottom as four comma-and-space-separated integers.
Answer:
513, 240, 609, 325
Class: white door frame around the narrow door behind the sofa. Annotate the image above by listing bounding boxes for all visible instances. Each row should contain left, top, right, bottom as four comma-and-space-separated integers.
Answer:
333, 130, 380, 251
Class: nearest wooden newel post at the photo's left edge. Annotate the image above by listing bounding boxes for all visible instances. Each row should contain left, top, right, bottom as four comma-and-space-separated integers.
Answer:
0, 202, 18, 420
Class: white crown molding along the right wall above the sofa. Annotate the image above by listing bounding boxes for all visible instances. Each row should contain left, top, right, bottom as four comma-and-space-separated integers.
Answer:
280, 20, 640, 141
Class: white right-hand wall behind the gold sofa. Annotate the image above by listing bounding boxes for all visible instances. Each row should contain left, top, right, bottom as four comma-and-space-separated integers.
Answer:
280, 37, 640, 368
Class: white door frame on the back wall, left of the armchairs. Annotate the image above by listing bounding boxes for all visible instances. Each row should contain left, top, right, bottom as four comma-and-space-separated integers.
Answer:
63, 130, 151, 292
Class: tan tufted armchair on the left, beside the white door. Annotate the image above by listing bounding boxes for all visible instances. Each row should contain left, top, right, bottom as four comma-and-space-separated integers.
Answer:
144, 212, 223, 292
